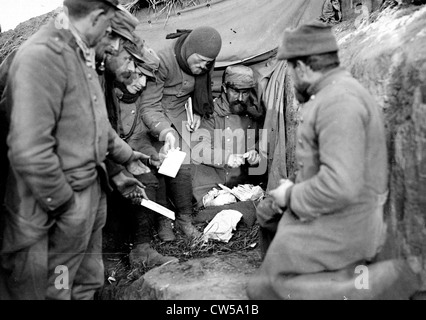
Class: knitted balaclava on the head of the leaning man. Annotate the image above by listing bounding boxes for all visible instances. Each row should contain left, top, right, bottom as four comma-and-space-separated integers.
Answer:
182, 27, 222, 59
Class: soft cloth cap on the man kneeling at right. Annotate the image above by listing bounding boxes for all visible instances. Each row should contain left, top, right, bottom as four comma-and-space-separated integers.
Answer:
277, 20, 339, 60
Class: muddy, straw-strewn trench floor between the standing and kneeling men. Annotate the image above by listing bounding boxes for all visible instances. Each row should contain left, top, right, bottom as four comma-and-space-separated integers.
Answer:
96, 204, 261, 300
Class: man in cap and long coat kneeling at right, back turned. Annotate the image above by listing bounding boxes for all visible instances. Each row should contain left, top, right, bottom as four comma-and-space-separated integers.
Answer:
248, 21, 388, 300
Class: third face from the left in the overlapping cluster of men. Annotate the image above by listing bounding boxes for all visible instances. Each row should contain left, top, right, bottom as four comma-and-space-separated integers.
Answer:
105, 48, 135, 84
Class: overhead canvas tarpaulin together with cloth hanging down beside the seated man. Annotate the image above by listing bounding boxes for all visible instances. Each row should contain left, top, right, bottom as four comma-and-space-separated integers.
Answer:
136, 0, 323, 190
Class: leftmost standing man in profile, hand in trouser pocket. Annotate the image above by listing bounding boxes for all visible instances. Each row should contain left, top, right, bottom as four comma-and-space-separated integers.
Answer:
0, 0, 150, 300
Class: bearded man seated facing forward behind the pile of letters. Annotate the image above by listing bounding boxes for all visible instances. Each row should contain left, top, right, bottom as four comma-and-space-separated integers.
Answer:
192, 65, 265, 207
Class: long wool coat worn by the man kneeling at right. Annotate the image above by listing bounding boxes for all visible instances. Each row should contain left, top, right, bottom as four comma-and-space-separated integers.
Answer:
255, 68, 388, 297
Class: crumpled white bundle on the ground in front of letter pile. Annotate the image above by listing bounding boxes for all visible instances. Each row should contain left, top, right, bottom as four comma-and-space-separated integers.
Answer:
203, 210, 243, 242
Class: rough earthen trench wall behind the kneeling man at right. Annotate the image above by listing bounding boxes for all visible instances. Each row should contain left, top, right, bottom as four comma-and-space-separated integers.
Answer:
338, 6, 426, 290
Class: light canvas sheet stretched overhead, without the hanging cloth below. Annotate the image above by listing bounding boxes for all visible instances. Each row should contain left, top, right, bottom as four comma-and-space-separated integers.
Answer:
136, 0, 323, 68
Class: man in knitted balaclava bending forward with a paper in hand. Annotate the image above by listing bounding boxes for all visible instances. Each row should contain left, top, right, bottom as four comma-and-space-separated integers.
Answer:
142, 26, 222, 241
